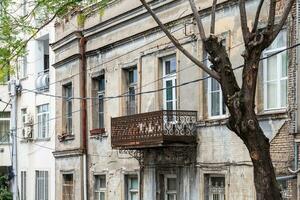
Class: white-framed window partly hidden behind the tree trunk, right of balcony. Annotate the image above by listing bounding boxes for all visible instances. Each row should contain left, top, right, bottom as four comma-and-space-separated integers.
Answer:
204, 50, 226, 118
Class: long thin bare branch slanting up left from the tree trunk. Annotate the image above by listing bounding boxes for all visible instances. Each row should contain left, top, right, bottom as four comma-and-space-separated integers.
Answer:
140, 0, 220, 81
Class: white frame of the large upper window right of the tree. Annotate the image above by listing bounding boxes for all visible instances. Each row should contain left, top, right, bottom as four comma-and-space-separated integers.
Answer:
263, 30, 288, 111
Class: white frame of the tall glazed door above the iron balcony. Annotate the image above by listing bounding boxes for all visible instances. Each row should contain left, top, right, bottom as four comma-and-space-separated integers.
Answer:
162, 55, 177, 110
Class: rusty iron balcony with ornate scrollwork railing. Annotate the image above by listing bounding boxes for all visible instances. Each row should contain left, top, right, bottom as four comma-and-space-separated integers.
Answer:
111, 110, 197, 149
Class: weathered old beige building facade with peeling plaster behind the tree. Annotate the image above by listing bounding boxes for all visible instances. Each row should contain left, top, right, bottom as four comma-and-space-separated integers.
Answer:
52, 0, 298, 200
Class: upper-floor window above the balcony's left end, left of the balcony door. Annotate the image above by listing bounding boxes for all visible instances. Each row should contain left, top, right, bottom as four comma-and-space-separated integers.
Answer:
126, 67, 137, 115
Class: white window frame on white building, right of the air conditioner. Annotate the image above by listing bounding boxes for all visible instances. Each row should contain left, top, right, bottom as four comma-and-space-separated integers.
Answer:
36, 104, 50, 139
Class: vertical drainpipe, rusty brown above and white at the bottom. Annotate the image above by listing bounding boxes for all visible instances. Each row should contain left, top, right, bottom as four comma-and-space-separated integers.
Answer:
79, 34, 89, 200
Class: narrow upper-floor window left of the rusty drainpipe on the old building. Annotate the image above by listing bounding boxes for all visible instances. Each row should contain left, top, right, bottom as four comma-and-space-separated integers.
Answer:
64, 84, 73, 135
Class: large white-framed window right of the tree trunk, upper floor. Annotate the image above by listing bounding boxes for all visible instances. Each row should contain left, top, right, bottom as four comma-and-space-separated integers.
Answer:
263, 31, 287, 110
